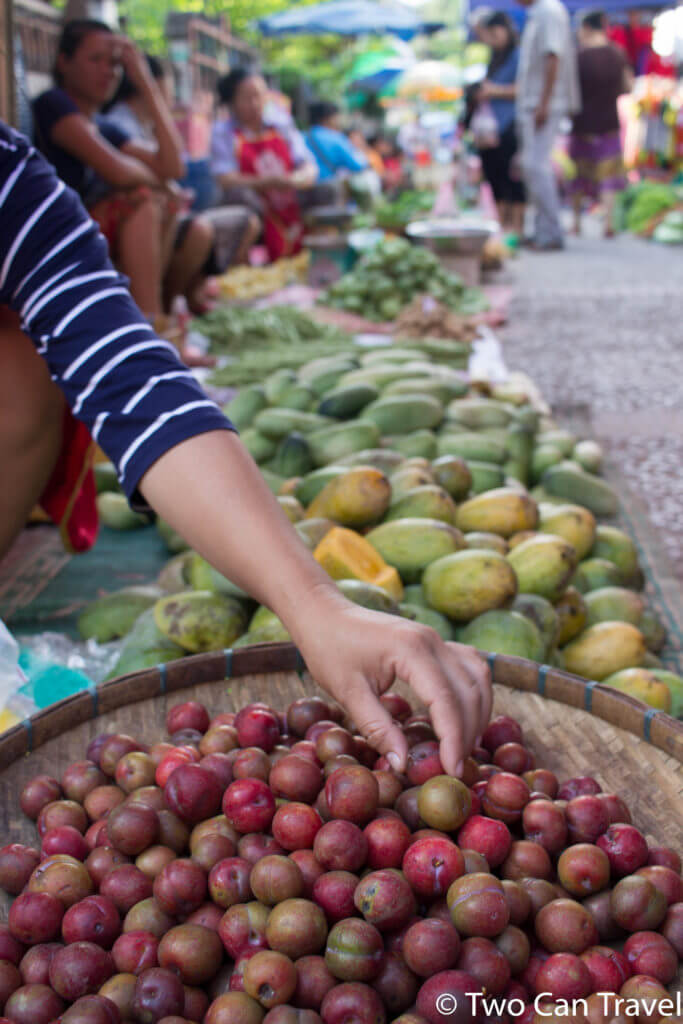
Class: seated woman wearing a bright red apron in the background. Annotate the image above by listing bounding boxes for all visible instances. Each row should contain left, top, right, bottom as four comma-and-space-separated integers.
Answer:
211, 68, 317, 260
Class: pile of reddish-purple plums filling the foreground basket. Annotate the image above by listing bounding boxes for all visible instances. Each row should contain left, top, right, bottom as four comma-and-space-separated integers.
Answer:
0, 692, 683, 1024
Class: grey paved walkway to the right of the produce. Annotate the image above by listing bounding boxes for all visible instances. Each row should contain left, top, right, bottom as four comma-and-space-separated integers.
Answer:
501, 232, 683, 579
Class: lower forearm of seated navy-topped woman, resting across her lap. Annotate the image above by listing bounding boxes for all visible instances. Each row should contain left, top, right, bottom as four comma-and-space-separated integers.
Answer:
51, 114, 159, 188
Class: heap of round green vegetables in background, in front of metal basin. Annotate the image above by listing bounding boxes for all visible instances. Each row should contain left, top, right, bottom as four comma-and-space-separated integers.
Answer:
321, 239, 487, 321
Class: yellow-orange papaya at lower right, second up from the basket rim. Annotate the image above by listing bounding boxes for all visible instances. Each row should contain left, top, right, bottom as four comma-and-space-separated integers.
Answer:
564, 623, 646, 680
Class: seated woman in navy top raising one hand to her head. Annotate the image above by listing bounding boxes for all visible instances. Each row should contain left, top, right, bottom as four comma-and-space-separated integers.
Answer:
34, 19, 213, 317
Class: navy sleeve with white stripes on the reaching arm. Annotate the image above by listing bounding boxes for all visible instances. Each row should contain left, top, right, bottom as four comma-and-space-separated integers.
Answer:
0, 122, 233, 498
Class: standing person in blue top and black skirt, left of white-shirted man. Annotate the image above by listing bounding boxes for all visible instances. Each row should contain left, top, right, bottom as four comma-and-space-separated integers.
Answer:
475, 11, 525, 236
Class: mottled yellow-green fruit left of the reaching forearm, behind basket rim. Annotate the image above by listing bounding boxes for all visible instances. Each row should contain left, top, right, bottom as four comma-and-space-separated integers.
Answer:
155, 590, 247, 654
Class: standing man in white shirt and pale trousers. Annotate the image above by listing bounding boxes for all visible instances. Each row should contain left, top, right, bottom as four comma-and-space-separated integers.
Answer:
517, 0, 581, 251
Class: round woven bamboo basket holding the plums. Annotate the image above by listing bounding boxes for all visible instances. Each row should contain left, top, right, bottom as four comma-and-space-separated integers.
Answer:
0, 643, 683, 983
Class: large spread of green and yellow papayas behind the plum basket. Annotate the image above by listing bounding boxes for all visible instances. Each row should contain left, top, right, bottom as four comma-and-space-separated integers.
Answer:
88, 340, 683, 716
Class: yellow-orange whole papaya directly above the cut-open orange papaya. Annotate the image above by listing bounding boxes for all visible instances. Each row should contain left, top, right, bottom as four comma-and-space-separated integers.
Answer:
306, 466, 391, 526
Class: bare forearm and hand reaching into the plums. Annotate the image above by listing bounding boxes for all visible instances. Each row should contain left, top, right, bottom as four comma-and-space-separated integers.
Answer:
140, 431, 492, 774
